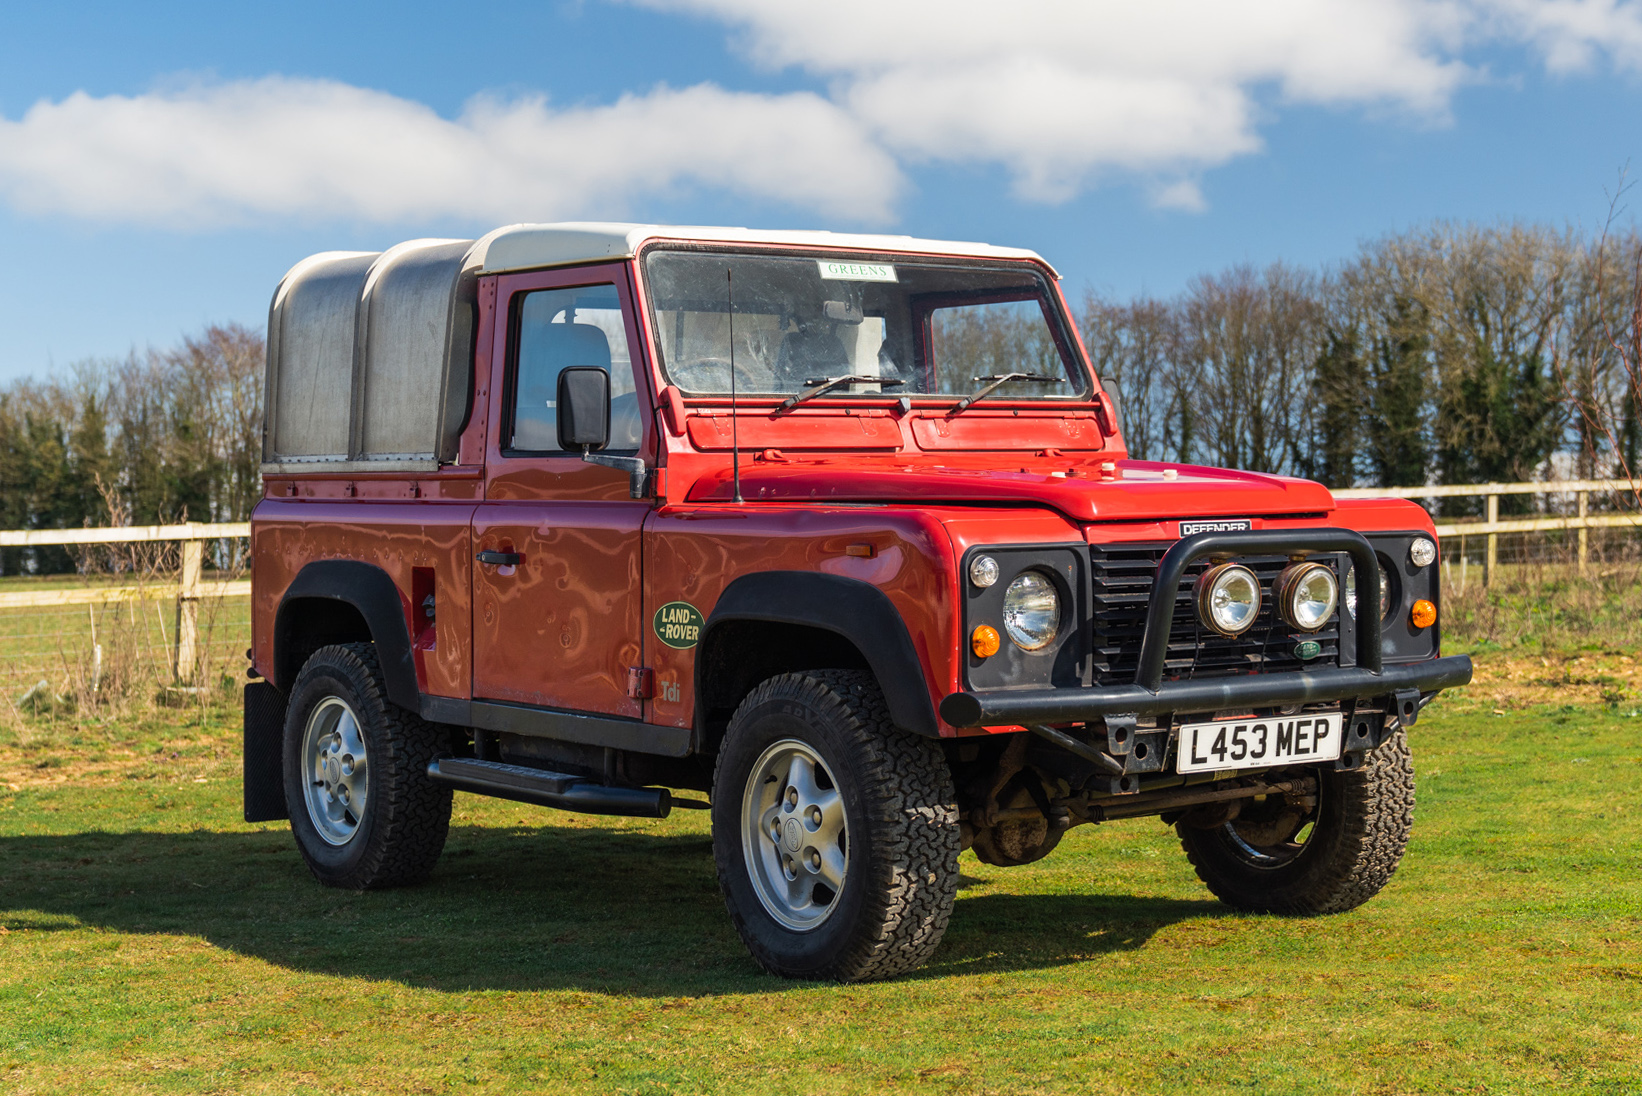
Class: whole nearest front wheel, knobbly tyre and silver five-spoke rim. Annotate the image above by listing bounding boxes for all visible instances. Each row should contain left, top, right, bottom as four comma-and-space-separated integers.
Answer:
713, 670, 961, 981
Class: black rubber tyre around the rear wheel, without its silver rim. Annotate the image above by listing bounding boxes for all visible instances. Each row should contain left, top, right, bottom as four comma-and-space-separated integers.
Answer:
284, 642, 452, 891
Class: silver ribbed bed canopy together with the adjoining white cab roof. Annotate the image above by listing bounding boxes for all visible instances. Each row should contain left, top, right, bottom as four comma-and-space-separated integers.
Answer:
263, 222, 1043, 472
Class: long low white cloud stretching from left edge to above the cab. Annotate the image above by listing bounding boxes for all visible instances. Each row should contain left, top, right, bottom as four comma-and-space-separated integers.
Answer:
0, 77, 901, 227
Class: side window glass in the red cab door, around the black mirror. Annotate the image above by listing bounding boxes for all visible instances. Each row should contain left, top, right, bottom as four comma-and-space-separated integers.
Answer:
507, 286, 644, 452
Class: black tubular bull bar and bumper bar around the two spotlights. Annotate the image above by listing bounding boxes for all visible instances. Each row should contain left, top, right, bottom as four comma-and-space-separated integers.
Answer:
941, 529, 1471, 726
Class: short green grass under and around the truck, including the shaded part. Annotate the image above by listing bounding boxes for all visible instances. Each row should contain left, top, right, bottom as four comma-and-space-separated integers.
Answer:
0, 690, 1642, 1093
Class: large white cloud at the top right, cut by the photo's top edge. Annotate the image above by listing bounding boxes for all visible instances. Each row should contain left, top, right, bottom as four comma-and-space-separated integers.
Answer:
629, 0, 1642, 205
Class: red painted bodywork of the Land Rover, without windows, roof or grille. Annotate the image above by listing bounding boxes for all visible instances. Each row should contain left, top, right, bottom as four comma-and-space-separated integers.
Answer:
251, 241, 1432, 749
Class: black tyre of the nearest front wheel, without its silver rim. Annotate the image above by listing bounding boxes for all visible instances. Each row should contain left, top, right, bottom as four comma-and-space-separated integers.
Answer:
713, 670, 961, 983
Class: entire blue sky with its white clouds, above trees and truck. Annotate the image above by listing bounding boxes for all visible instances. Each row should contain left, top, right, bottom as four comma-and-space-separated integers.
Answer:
0, 0, 1642, 381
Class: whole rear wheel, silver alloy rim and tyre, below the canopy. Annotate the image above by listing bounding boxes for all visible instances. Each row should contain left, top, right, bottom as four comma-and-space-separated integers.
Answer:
284, 642, 452, 889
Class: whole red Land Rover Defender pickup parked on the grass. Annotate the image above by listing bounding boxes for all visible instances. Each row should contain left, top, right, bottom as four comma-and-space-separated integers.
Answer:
245, 223, 1471, 979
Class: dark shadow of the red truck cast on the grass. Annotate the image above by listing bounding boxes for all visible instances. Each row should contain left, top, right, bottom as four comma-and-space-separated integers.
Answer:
0, 827, 1227, 996
